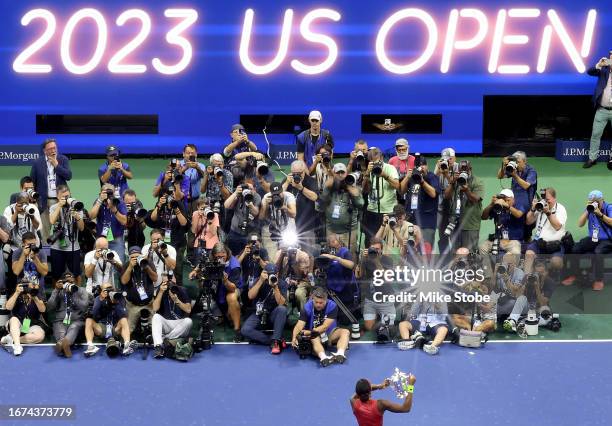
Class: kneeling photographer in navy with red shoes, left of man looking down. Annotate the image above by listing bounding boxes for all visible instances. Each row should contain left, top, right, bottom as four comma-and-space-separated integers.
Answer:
242, 263, 287, 355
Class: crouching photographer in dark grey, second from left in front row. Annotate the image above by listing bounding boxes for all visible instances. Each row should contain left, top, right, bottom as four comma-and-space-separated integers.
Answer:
47, 272, 89, 358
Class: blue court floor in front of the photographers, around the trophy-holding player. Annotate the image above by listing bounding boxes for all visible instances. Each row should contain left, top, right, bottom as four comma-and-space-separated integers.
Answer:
0, 341, 612, 426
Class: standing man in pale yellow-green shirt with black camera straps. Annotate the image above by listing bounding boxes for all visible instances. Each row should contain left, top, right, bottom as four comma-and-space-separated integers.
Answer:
361, 148, 400, 245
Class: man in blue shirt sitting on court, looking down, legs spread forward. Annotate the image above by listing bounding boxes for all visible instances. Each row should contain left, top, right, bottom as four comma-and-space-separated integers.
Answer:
291, 287, 350, 367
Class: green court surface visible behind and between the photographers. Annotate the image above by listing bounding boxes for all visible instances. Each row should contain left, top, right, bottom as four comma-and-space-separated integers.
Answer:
0, 156, 612, 340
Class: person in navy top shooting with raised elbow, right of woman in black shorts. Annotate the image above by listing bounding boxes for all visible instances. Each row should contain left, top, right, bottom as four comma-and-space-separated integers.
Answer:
89, 183, 127, 261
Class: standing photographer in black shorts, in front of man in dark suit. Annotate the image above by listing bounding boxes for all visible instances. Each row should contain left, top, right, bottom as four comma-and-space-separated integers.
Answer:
47, 185, 85, 284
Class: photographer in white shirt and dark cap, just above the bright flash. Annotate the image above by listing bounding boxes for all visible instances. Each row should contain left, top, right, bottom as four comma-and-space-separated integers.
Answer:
259, 182, 297, 259
